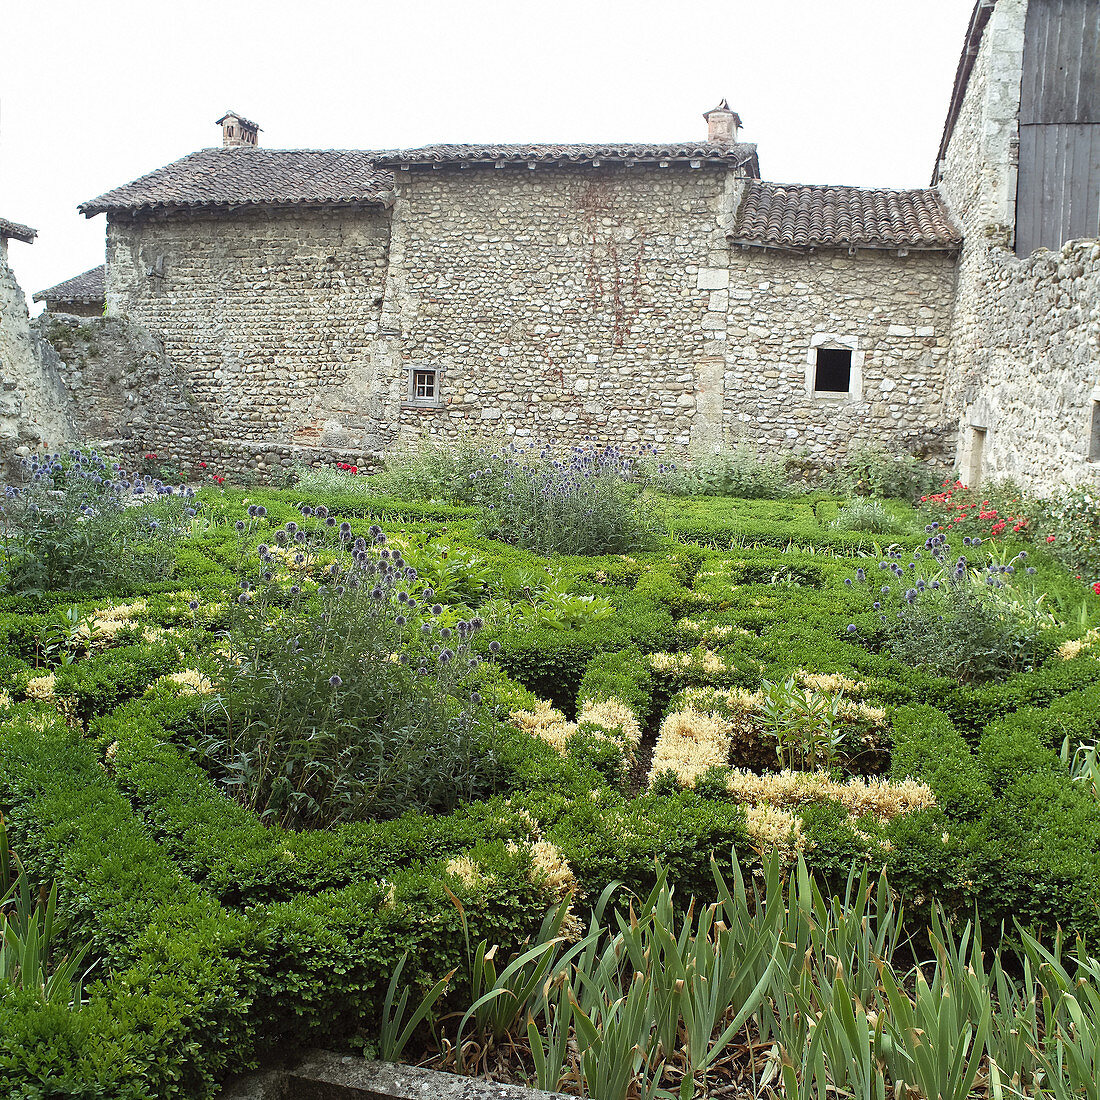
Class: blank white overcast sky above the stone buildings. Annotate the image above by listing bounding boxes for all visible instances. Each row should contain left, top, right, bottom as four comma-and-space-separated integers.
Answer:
0, 0, 972, 310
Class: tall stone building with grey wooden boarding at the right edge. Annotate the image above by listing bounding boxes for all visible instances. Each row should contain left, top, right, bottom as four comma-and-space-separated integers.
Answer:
933, 0, 1100, 490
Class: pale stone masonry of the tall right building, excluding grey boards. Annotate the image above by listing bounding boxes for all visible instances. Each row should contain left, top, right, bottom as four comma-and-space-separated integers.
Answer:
939, 0, 1100, 493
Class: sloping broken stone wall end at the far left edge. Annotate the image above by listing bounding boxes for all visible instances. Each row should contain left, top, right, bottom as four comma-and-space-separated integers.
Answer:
0, 251, 75, 471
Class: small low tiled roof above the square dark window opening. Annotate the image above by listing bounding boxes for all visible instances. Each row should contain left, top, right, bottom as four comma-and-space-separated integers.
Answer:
728, 179, 963, 250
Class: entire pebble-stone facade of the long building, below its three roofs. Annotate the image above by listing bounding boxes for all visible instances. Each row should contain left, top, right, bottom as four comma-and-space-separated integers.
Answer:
96, 164, 954, 475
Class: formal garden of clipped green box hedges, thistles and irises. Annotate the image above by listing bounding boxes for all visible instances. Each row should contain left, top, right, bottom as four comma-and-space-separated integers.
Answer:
0, 442, 1100, 1100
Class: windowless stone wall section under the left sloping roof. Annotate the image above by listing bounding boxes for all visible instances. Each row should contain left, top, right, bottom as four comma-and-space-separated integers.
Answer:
107, 206, 388, 473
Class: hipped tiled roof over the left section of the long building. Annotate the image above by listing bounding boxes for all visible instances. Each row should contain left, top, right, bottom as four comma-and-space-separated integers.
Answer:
78, 145, 393, 218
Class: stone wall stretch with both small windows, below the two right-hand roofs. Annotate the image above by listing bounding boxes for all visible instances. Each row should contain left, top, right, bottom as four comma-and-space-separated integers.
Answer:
380, 165, 954, 459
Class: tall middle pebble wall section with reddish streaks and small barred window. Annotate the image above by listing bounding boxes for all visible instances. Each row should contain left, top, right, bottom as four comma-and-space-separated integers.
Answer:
385, 164, 726, 448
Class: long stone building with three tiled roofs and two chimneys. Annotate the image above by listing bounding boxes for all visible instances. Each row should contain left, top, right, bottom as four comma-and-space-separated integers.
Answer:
70, 101, 961, 477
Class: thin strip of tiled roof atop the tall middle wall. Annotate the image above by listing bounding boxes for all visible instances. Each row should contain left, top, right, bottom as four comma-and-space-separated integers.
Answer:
377, 142, 759, 176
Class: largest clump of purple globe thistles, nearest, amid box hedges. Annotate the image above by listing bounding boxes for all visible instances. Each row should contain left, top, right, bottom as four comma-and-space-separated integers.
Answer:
195, 505, 497, 827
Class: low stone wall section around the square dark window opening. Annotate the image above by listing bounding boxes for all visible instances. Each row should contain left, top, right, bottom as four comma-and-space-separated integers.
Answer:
725, 249, 955, 459
